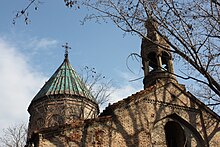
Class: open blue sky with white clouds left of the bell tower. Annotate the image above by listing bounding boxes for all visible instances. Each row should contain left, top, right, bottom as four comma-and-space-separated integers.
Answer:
0, 0, 143, 135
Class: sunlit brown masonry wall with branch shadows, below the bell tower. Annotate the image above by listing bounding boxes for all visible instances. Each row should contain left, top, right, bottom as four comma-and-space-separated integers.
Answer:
34, 84, 220, 147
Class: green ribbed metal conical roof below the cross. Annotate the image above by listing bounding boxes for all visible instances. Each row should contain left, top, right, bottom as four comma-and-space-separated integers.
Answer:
32, 57, 95, 102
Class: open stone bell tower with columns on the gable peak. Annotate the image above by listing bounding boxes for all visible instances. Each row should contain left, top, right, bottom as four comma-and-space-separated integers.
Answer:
141, 18, 176, 89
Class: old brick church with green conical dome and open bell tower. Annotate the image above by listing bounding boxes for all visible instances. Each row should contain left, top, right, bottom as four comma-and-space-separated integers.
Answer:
26, 21, 220, 147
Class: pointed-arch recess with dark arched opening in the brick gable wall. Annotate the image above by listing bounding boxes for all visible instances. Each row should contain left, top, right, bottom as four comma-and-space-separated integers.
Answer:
151, 113, 206, 147
